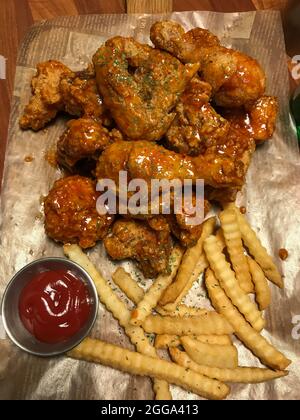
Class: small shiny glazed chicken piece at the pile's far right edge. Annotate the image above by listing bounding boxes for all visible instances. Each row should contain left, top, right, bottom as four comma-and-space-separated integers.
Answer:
220, 96, 278, 143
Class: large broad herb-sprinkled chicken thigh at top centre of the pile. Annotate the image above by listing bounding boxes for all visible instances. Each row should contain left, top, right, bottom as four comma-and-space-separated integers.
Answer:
93, 36, 199, 141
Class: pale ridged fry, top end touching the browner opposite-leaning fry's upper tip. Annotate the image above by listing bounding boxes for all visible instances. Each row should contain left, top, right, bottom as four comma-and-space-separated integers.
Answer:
204, 236, 265, 331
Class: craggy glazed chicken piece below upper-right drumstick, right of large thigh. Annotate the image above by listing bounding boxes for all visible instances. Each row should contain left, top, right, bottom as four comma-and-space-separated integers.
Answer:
166, 77, 229, 156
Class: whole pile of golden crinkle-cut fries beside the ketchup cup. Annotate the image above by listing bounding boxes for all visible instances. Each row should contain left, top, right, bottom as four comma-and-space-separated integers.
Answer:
64, 204, 290, 400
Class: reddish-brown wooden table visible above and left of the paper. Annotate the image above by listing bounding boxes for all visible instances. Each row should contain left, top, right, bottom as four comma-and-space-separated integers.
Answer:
0, 0, 300, 185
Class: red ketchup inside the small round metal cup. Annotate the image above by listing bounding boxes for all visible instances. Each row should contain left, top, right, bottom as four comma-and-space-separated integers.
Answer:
19, 270, 91, 343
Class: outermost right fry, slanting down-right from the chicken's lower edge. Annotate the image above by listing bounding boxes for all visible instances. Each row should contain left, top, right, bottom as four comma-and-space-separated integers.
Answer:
226, 204, 283, 288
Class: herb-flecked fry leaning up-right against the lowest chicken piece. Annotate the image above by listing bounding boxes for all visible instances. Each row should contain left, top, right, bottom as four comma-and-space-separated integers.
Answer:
130, 247, 183, 325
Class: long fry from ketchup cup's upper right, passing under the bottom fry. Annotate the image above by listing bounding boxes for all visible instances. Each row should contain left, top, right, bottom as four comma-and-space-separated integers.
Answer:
64, 245, 172, 399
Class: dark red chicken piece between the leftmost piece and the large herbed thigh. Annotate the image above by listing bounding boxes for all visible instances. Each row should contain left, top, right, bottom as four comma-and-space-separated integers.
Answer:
60, 65, 112, 126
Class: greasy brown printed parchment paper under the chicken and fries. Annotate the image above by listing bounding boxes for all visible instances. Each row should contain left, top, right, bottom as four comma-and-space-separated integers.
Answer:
0, 12, 300, 400
